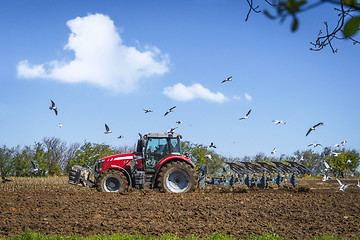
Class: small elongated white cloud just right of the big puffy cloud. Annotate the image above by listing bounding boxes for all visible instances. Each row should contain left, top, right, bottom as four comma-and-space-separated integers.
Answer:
163, 83, 227, 103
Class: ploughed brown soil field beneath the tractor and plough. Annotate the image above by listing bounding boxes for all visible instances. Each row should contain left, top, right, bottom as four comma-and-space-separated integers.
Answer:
0, 178, 360, 239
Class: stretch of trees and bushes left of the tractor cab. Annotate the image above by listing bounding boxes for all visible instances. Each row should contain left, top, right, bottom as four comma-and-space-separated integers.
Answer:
0, 137, 135, 177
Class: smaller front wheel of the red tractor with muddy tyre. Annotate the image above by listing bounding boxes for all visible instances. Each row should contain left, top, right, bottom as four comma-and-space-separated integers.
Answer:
96, 170, 129, 193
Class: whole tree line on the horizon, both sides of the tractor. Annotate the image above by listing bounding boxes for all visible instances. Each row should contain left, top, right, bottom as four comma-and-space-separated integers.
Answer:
0, 137, 360, 177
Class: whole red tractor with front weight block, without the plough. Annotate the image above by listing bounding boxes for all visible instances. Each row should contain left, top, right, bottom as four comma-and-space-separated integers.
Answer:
69, 133, 197, 193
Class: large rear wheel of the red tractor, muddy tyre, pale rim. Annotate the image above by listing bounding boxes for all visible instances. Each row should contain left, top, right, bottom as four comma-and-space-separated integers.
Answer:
157, 162, 197, 193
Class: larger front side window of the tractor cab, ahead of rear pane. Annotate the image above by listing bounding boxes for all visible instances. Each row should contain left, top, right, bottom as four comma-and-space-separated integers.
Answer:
145, 138, 169, 172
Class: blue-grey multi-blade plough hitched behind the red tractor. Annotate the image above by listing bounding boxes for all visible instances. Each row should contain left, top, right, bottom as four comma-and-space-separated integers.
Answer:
197, 162, 311, 188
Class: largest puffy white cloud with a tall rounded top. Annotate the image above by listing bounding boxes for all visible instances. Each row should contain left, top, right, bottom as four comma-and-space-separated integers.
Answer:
17, 14, 169, 92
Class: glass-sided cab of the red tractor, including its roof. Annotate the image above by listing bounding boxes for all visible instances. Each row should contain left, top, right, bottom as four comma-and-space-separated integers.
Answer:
138, 133, 182, 173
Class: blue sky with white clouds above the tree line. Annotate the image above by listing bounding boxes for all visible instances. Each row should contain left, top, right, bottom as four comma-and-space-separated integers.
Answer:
0, 0, 360, 158
